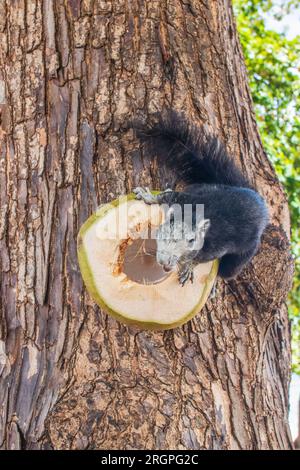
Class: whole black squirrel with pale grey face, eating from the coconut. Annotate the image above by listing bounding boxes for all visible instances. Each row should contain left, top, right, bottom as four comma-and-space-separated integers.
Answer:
133, 110, 268, 285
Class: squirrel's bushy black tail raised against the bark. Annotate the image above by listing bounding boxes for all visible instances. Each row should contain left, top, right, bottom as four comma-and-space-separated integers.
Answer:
133, 110, 251, 188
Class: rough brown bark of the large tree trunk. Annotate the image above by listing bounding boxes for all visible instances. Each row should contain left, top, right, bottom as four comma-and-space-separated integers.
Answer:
0, 0, 292, 449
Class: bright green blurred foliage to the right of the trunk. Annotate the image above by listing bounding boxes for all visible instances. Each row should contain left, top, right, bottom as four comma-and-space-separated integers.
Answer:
233, 0, 300, 374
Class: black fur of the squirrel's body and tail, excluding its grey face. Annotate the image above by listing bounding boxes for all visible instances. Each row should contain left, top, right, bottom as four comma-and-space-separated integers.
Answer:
135, 111, 268, 279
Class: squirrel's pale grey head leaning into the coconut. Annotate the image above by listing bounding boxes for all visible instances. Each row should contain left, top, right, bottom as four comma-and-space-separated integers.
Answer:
156, 209, 210, 271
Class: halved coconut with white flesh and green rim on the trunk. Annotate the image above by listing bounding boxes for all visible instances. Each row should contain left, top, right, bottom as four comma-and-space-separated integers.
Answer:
78, 195, 217, 329
